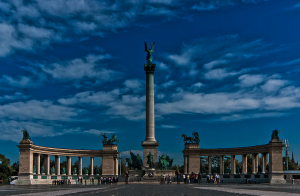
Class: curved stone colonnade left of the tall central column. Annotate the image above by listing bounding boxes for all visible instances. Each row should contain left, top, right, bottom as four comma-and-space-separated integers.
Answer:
18, 139, 119, 184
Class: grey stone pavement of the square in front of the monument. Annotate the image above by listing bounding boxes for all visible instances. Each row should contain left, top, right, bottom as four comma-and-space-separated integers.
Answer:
0, 183, 300, 196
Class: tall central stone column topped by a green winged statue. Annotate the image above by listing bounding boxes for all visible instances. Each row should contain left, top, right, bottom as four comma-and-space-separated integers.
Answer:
142, 42, 159, 169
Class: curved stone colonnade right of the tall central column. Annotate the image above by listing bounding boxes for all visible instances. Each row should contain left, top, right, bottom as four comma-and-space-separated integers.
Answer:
182, 139, 285, 183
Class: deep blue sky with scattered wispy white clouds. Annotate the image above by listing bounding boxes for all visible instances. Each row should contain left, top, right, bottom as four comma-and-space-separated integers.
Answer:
0, 0, 300, 168
